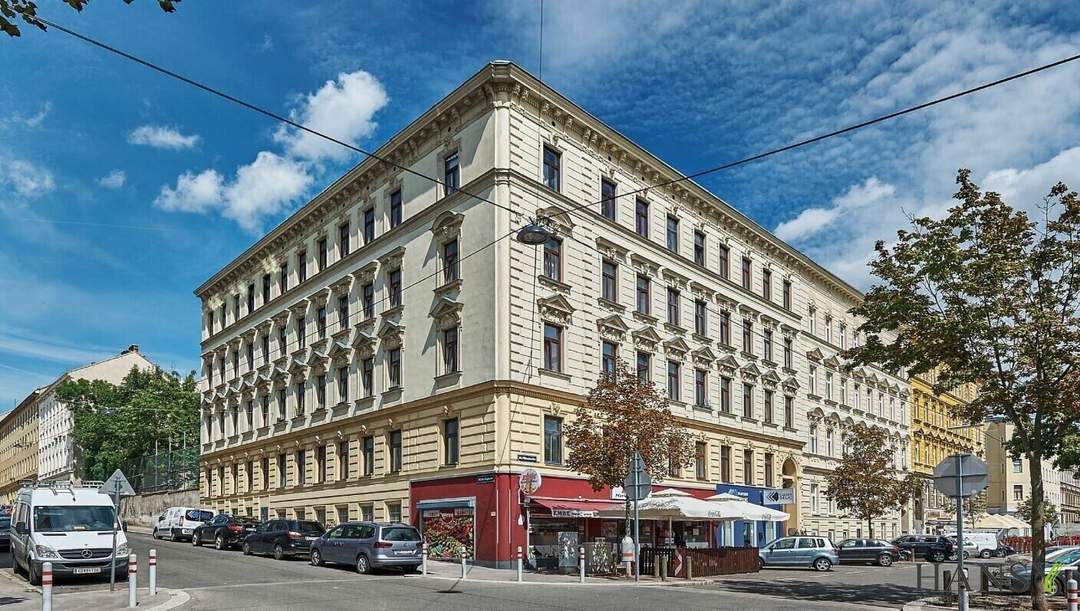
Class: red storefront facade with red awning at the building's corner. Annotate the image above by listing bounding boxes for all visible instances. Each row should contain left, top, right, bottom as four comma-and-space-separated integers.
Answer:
409, 473, 716, 568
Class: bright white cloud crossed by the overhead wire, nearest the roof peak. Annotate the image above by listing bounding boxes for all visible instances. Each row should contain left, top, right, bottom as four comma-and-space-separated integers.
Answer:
274, 70, 389, 161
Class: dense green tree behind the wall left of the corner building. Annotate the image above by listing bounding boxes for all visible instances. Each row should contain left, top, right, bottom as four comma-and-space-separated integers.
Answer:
56, 368, 200, 479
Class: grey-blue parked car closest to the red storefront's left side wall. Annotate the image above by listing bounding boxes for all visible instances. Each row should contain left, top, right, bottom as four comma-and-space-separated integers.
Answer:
311, 521, 422, 574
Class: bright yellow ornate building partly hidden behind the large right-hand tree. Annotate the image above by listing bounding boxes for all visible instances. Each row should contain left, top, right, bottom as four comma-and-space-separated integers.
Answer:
905, 371, 985, 533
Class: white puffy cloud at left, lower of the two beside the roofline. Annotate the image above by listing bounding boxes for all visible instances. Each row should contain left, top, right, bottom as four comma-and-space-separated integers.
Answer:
154, 151, 313, 232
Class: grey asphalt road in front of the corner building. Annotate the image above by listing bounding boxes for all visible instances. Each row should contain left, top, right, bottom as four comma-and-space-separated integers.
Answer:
0, 533, 1002, 611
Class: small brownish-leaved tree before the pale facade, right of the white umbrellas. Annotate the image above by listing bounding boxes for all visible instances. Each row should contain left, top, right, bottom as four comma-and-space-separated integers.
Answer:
825, 424, 921, 539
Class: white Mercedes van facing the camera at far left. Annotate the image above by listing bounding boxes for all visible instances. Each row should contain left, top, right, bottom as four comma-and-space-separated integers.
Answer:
11, 481, 127, 585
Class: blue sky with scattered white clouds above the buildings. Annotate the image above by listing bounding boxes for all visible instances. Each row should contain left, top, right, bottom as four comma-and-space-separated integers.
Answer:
0, 0, 1080, 409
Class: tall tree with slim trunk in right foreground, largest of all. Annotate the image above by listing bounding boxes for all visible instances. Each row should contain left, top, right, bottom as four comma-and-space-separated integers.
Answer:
845, 169, 1080, 610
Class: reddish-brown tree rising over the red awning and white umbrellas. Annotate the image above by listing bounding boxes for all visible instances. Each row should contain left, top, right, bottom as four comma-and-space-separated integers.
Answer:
564, 361, 694, 490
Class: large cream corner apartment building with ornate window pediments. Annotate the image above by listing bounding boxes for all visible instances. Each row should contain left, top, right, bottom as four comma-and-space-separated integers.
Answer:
195, 62, 910, 566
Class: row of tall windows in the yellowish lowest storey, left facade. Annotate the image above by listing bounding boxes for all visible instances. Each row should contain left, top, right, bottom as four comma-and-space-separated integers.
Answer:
206, 418, 460, 495
